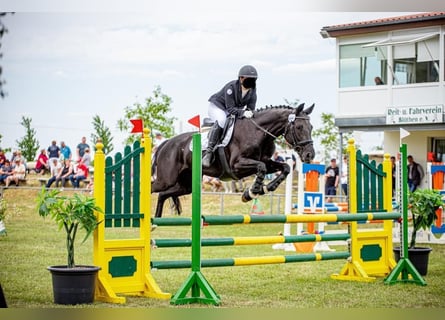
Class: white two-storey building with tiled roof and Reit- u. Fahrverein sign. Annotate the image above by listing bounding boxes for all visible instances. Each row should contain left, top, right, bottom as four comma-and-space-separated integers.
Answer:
320, 12, 445, 190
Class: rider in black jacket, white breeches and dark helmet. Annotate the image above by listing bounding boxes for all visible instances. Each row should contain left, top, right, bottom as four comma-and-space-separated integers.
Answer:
202, 65, 258, 167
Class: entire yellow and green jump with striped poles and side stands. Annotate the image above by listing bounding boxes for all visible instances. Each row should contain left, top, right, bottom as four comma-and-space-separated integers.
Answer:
94, 129, 423, 305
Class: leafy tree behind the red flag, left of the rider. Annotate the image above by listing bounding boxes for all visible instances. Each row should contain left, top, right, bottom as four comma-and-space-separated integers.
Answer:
117, 86, 176, 144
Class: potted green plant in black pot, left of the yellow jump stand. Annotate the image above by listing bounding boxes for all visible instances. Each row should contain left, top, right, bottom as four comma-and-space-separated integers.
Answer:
37, 188, 101, 304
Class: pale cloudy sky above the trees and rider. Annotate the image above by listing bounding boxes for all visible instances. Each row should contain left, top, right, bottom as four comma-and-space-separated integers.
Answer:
0, 0, 438, 161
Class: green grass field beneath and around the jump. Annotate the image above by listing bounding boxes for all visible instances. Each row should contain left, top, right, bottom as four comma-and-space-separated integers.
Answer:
0, 188, 445, 308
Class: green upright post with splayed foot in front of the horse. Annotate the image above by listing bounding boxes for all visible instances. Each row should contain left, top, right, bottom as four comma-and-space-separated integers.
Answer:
170, 132, 221, 305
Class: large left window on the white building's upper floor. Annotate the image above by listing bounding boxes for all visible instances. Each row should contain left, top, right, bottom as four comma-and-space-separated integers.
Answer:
339, 44, 387, 88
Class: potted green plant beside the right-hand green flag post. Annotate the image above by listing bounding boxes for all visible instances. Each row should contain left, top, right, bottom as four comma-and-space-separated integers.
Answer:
394, 189, 443, 275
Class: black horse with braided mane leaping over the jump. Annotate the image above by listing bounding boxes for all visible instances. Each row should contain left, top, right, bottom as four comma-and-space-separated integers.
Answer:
151, 103, 315, 217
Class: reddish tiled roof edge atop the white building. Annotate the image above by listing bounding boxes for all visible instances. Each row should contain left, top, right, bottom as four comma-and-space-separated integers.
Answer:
320, 12, 445, 38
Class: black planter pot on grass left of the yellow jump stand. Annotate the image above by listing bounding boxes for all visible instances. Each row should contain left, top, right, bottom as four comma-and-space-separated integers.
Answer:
47, 265, 100, 304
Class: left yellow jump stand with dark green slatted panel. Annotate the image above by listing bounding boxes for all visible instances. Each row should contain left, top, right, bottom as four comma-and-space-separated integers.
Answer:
93, 129, 171, 303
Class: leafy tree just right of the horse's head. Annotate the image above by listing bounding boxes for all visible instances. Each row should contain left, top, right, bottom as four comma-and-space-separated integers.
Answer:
312, 112, 352, 161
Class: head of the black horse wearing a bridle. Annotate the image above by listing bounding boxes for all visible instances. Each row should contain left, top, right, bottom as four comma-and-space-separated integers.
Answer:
284, 103, 315, 163
